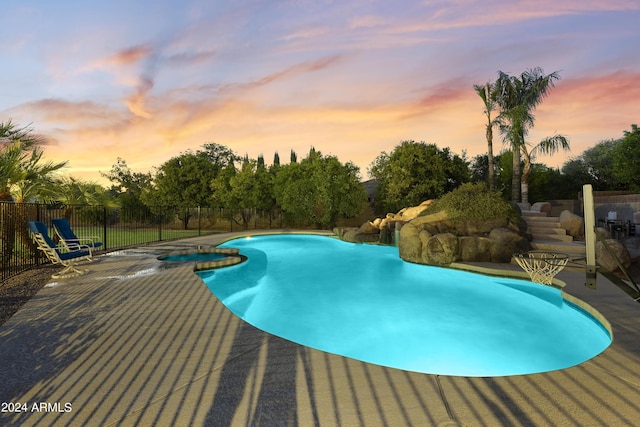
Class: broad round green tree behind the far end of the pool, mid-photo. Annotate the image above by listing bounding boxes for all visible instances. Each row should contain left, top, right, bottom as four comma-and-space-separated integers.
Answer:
274, 149, 367, 228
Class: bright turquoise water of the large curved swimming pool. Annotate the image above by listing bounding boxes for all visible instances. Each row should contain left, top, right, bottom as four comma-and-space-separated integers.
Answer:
198, 235, 611, 376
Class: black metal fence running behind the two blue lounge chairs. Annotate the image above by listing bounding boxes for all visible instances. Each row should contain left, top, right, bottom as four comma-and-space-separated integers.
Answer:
0, 202, 283, 283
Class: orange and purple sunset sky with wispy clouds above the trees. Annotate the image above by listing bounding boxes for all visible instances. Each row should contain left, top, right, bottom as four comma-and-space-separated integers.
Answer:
0, 0, 640, 181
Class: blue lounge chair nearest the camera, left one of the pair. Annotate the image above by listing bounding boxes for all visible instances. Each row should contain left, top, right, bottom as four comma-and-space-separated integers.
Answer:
29, 221, 91, 279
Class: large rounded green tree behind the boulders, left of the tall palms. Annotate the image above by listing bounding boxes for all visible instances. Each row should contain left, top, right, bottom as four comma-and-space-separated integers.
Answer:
369, 141, 471, 213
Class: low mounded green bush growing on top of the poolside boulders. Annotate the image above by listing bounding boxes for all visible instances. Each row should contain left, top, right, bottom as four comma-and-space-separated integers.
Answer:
420, 182, 519, 221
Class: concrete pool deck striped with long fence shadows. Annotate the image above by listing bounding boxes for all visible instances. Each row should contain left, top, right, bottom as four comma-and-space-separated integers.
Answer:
0, 234, 640, 426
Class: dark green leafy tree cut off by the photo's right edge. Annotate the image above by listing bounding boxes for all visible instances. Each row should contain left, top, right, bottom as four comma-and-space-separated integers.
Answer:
613, 124, 640, 191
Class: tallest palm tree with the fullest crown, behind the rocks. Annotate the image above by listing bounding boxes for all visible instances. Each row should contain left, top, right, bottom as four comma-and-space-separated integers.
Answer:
495, 67, 560, 202
